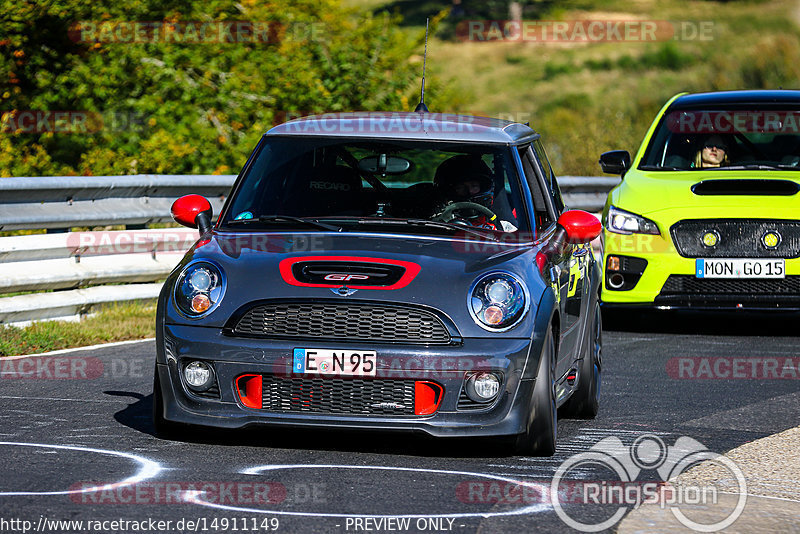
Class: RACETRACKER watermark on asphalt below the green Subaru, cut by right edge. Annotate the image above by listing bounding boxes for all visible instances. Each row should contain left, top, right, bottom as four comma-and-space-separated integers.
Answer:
667, 356, 800, 380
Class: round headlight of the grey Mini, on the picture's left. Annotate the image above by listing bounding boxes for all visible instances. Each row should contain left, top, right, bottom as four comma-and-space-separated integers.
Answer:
175, 261, 225, 317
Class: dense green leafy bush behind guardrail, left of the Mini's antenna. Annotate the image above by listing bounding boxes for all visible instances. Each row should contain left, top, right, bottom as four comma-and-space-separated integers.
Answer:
0, 0, 434, 176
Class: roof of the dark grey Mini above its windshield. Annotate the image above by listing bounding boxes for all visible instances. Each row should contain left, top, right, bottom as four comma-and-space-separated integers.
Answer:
267, 111, 539, 144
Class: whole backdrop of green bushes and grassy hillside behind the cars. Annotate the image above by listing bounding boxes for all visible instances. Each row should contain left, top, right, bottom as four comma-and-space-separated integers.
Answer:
0, 0, 800, 176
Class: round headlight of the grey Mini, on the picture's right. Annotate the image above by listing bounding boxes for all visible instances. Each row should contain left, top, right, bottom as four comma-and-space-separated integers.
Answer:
467, 272, 528, 332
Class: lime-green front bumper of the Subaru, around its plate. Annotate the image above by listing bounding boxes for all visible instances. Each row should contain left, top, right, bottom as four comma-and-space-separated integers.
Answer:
602, 231, 800, 310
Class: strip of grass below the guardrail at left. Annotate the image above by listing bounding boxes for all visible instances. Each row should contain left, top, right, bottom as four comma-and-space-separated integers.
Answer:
0, 303, 156, 356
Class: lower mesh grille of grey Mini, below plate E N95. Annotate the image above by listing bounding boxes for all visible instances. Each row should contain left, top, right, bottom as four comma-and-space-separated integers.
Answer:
262, 375, 414, 415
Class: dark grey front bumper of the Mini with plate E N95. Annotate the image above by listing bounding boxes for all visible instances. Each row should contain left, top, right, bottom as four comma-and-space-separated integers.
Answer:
156, 325, 542, 437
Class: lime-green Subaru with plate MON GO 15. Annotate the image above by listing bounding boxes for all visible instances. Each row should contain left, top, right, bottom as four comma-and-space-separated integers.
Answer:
600, 90, 800, 309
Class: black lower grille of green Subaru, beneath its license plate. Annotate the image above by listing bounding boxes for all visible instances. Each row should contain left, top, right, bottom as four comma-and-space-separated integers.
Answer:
654, 275, 800, 309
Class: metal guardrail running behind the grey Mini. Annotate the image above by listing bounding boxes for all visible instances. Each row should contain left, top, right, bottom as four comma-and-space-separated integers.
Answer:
0, 175, 620, 325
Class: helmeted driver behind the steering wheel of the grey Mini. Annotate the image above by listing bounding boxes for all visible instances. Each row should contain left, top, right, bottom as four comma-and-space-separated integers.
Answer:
433, 155, 517, 232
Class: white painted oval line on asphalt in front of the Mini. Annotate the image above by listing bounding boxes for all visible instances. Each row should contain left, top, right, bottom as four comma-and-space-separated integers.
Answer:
183, 464, 553, 519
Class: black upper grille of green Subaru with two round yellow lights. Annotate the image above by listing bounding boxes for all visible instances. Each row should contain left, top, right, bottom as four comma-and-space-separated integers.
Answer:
670, 219, 800, 258
